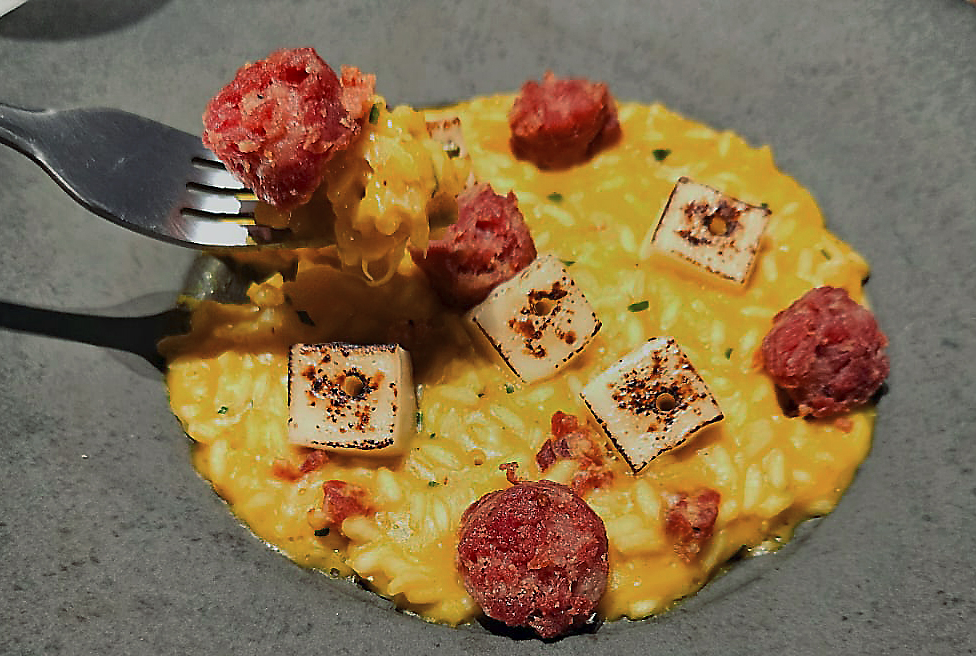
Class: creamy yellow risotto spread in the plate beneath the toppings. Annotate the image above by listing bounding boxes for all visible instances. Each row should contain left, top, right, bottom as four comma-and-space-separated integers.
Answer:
164, 95, 874, 624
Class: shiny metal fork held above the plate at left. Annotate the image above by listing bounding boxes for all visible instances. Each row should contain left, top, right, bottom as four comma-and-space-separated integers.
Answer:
0, 103, 270, 248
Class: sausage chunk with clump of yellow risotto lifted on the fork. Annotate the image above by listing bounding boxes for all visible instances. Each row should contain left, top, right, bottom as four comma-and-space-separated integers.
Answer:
203, 48, 470, 284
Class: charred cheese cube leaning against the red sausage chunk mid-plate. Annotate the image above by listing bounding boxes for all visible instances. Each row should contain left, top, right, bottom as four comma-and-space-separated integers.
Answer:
468, 255, 601, 382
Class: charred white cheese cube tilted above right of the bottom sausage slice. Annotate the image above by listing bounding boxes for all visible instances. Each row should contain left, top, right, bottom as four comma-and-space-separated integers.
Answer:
581, 337, 723, 473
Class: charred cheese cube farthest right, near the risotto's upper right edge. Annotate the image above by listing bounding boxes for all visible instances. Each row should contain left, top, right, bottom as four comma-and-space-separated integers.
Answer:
651, 178, 770, 285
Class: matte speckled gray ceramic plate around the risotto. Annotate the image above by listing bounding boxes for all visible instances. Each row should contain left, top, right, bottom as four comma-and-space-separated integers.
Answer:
0, 0, 976, 656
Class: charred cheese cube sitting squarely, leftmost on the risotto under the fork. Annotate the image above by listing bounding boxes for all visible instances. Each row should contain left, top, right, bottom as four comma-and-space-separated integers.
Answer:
288, 343, 416, 456
